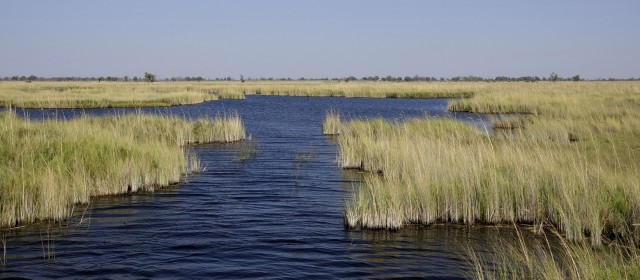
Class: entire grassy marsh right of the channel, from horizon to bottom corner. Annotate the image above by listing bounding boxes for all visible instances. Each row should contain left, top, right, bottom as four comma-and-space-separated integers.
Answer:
330, 83, 640, 278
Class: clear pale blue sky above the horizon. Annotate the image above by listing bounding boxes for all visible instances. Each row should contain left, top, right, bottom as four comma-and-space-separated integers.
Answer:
0, 0, 640, 78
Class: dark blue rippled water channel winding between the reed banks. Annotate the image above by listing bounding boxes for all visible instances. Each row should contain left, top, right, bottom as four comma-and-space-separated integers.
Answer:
0, 96, 504, 279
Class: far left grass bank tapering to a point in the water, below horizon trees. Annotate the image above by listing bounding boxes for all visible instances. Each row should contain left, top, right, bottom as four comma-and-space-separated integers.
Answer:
0, 82, 244, 108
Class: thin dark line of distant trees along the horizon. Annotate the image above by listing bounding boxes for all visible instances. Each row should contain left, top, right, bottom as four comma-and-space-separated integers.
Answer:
0, 72, 640, 82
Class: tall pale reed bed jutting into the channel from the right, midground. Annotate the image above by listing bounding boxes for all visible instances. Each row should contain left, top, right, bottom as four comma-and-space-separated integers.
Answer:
338, 116, 640, 245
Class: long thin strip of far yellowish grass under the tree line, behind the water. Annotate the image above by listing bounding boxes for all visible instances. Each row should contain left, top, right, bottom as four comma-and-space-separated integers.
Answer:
0, 81, 473, 108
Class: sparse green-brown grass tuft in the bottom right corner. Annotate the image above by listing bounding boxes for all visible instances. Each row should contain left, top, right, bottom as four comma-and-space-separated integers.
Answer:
466, 228, 640, 280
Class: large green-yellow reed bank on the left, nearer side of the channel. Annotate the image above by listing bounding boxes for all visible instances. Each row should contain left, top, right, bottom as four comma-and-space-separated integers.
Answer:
0, 111, 245, 228
